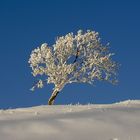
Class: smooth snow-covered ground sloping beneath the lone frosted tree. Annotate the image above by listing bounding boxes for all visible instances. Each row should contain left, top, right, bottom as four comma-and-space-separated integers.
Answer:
0, 100, 140, 140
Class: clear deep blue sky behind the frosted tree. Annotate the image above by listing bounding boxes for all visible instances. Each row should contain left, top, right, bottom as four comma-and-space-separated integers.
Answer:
0, 0, 140, 109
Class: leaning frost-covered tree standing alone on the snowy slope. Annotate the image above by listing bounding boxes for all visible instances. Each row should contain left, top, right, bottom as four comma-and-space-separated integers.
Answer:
29, 30, 118, 105
